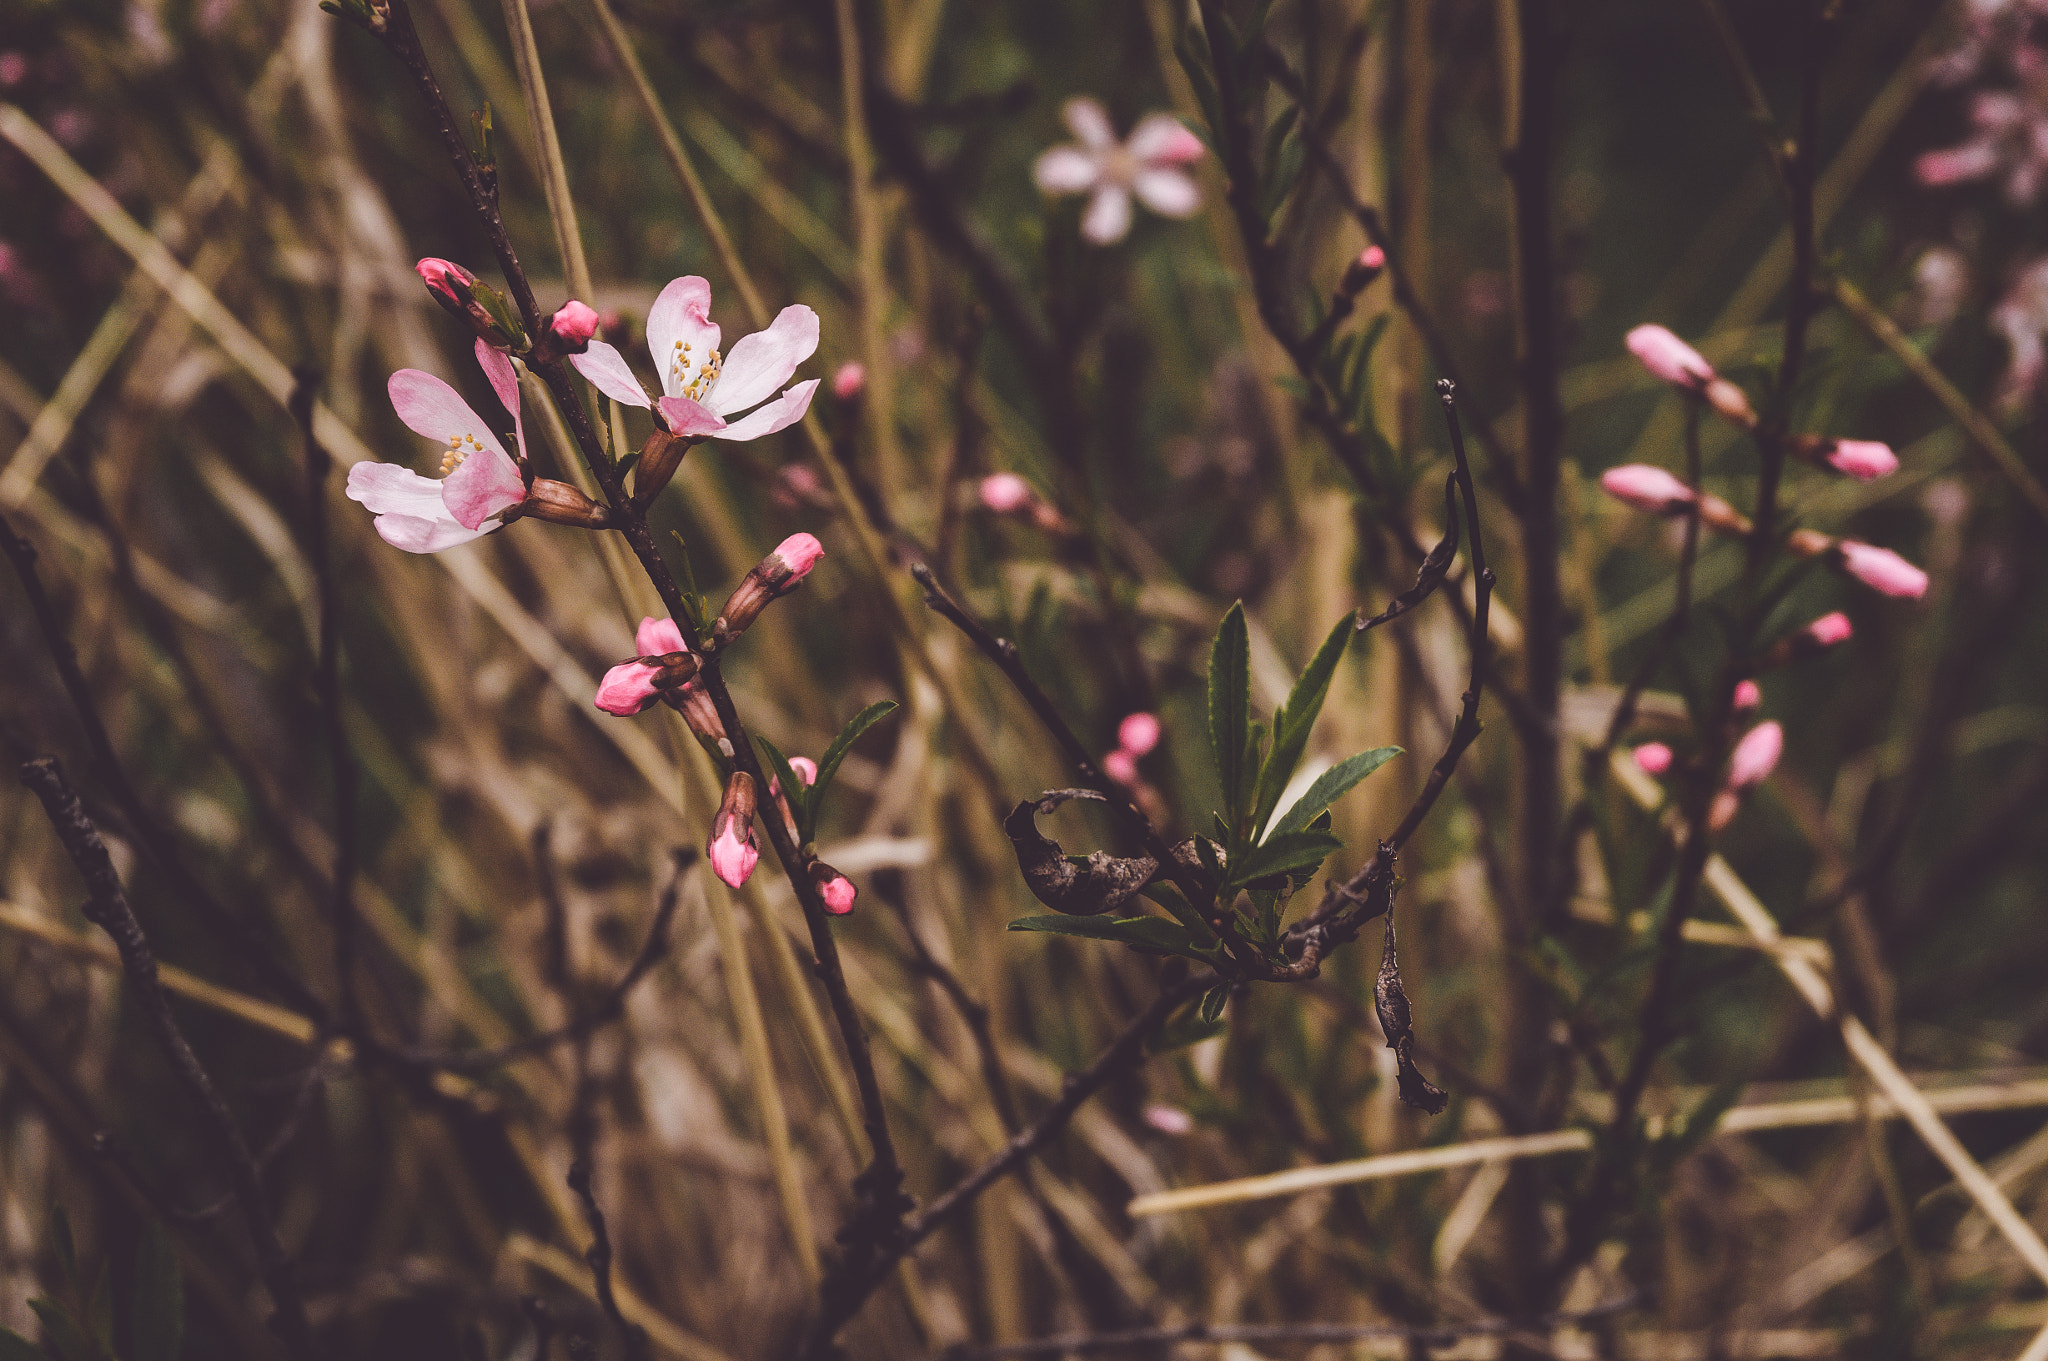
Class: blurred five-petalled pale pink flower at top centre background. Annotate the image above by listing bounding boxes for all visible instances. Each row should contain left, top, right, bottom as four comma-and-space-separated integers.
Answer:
1032, 96, 1204, 246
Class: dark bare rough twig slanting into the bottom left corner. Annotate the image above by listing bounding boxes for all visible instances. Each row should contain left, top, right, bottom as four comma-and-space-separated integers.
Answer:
20, 757, 315, 1359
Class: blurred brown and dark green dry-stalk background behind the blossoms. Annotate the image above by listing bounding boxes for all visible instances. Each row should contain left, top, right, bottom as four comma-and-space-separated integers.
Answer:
0, 0, 2048, 1361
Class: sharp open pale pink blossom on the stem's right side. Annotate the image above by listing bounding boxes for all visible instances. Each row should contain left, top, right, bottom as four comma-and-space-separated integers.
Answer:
569, 274, 817, 440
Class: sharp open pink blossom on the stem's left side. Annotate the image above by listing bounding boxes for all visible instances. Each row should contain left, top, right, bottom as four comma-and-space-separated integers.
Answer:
348, 340, 526, 553
